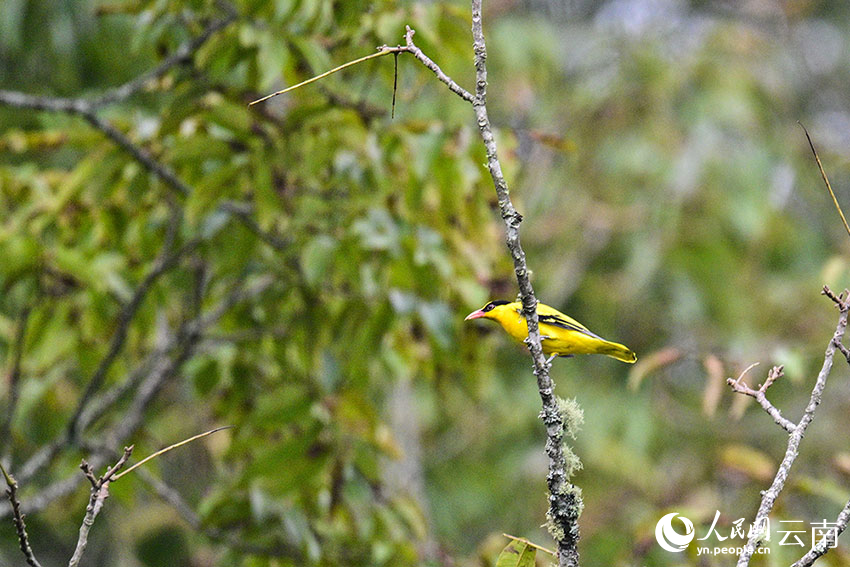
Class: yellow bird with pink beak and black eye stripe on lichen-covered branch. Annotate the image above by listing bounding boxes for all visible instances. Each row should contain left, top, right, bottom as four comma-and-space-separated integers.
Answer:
464, 300, 637, 364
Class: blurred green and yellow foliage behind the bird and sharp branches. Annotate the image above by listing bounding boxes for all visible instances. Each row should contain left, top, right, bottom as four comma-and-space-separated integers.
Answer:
0, 0, 850, 566
